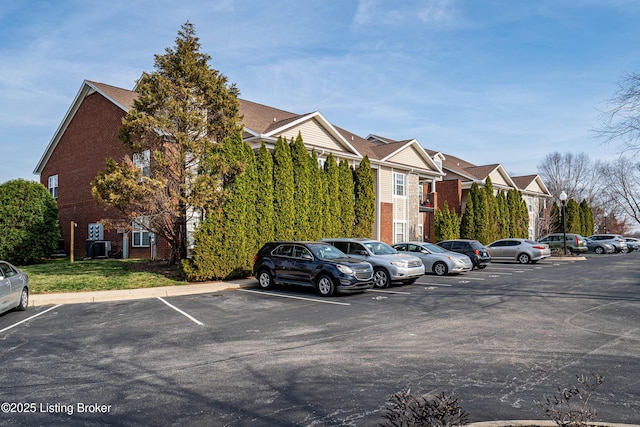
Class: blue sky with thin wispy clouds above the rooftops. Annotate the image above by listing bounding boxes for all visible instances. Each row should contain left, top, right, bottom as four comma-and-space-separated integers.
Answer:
0, 0, 640, 183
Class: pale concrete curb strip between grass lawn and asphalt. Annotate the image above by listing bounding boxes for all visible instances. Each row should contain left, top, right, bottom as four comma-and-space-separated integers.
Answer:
29, 278, 256, 307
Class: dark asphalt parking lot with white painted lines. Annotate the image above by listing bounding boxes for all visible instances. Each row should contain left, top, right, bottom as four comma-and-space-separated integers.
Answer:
0, 252, 640, 426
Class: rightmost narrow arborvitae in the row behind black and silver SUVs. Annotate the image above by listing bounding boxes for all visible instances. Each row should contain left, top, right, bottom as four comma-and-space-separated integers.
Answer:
353, 156, 376, 237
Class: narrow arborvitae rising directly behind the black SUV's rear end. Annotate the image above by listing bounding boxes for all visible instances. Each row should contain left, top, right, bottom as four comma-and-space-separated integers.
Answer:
255, 142, 275, 247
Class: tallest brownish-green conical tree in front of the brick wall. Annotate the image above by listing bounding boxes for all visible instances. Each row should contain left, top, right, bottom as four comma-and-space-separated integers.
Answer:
92, 22, 242, 264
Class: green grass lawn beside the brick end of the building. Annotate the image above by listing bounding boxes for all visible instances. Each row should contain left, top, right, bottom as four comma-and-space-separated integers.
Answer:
20, 259, 186, 294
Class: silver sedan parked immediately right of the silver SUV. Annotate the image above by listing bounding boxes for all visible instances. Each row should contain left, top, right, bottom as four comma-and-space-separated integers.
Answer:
393, 242, 473, 276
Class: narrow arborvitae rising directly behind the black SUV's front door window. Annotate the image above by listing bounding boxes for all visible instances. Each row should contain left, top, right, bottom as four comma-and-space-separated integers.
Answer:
290, 133, 312, 240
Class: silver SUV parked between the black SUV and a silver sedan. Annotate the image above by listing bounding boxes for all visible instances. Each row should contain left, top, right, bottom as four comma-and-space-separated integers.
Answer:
322, 238, 424, 288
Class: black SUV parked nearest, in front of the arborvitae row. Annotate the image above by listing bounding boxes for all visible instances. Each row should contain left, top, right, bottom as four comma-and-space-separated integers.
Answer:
253, 242, 373, 296
